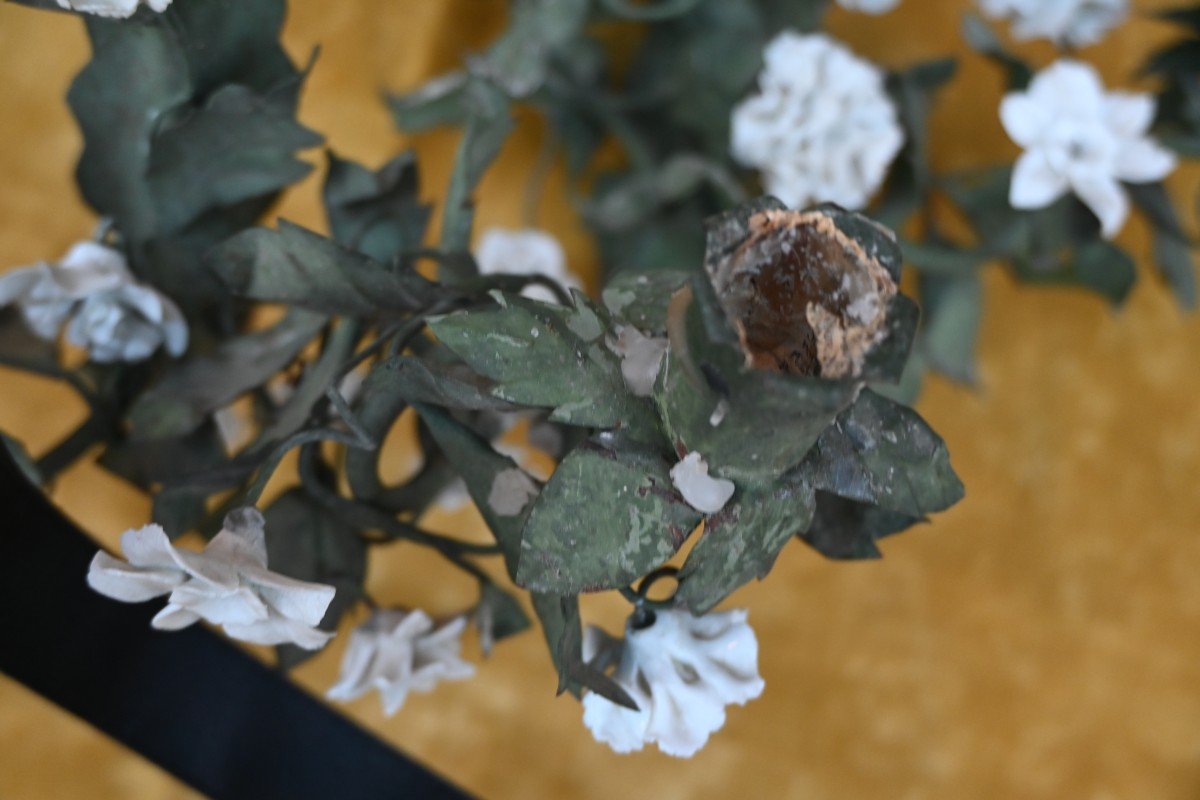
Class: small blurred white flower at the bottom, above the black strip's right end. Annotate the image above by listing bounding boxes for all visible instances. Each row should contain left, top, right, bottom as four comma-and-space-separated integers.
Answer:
326, 609, 475, 716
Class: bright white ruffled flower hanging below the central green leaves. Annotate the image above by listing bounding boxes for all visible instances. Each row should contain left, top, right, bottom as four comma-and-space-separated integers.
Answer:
583, 609, 764, 758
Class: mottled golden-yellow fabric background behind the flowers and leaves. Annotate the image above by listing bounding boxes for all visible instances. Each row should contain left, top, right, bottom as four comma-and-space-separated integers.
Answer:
0, 0, 1200, 800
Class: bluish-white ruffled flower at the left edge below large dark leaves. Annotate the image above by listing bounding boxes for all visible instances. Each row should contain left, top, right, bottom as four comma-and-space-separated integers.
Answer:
0, 241, 187, 363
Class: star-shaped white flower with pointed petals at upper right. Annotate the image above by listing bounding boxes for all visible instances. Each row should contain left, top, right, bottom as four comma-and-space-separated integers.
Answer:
1000, 59, 1176, 239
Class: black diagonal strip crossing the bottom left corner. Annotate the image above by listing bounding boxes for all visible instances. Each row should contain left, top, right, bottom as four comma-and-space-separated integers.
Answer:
0, 445, 466, 800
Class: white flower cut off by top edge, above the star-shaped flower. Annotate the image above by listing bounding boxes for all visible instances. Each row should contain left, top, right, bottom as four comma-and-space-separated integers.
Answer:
979, 0, 1129, 47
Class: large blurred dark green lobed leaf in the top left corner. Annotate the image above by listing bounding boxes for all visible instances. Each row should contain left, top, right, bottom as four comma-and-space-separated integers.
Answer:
68, 0, 307, 246
